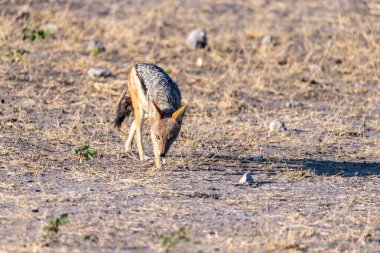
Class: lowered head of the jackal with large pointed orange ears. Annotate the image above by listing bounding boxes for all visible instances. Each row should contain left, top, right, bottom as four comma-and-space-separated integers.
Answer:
149, 101, 187, 157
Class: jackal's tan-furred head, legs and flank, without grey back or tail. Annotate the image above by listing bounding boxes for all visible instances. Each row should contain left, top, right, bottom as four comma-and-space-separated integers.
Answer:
125, 67, 187, 168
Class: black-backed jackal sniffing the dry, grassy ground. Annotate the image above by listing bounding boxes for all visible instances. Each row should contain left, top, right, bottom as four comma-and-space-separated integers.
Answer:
114, 63, 187, 168
